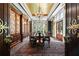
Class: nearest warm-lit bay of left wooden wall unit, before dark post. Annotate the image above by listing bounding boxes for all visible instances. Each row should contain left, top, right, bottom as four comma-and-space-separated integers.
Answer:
9, 8, 21, 47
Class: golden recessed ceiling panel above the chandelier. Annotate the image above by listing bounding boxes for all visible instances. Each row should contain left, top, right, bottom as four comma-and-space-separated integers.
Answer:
26, 3, 54, 16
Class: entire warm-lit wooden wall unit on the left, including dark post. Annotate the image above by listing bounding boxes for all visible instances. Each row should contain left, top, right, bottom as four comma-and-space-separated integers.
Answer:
9, 6, 28, 48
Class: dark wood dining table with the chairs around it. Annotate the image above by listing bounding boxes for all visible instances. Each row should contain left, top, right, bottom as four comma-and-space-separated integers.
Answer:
30, 33, 50, 47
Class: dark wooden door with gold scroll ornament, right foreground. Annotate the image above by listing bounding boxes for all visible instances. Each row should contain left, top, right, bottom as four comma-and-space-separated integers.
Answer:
65, 3, 79, 55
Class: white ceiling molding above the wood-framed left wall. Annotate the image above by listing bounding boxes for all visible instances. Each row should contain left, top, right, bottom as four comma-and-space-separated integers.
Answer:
10, 3, 32, 20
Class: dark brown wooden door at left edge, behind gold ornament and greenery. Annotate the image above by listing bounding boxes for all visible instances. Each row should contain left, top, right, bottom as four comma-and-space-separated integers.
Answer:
0, 3, 10, 55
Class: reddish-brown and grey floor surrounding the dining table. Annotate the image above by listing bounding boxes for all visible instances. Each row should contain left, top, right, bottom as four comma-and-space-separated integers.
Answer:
10, 37, 65, 56
